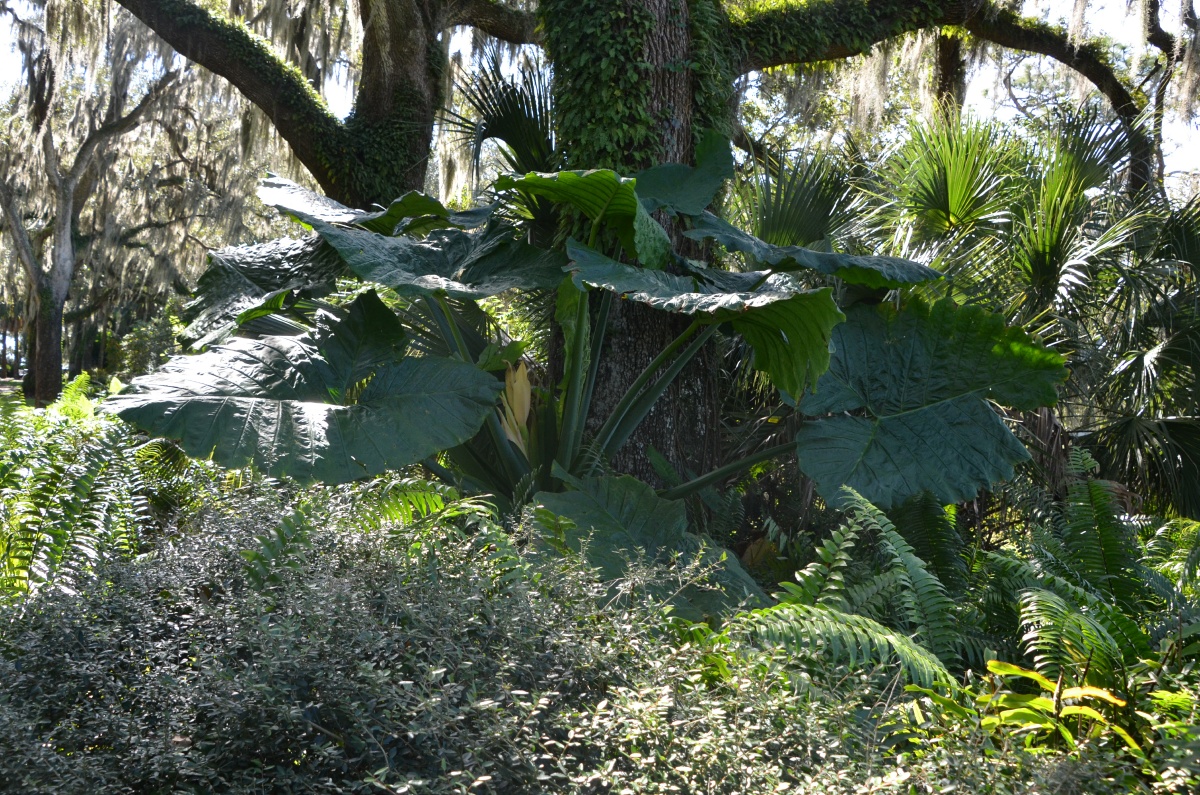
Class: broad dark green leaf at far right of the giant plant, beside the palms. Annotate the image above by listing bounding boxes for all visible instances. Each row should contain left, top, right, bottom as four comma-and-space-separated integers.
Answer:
797, 299, 1067, 508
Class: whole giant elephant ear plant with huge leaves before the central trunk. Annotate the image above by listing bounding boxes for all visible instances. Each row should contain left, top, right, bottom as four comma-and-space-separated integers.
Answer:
100, 136, 1064, 614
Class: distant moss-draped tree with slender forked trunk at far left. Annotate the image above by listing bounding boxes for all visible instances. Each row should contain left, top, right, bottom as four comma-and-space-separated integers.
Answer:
0, 2, 297, 405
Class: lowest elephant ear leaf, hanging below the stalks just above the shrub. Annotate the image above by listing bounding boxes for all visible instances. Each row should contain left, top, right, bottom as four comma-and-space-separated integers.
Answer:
534, 476, 767, 621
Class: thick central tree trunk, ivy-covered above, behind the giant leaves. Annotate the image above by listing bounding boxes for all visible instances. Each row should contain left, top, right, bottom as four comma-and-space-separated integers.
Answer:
540, 0, 732, 482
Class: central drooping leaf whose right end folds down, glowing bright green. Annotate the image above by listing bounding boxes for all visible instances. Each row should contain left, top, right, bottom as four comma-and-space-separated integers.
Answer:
566, 240, 845, 395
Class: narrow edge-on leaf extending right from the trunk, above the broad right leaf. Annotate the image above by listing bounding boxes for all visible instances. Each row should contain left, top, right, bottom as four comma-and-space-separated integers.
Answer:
684, 213, 942, 289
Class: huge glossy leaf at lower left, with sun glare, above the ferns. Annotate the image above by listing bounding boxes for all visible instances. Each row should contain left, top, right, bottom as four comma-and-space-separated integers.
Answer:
104, 293, 502, 483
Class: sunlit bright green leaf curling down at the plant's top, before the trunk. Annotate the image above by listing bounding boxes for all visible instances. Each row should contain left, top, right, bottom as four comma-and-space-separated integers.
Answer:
496, 168, 671, 269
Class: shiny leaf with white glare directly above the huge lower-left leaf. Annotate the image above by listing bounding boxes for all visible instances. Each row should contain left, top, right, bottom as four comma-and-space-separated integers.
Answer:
180, 235, 346, 349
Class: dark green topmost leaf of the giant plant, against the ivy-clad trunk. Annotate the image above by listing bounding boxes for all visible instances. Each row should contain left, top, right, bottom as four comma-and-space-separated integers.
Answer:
635, 130, 733, 215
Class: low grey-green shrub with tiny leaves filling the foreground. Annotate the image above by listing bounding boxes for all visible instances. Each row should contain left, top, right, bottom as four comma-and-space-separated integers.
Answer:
0, 494, 1147, 795
